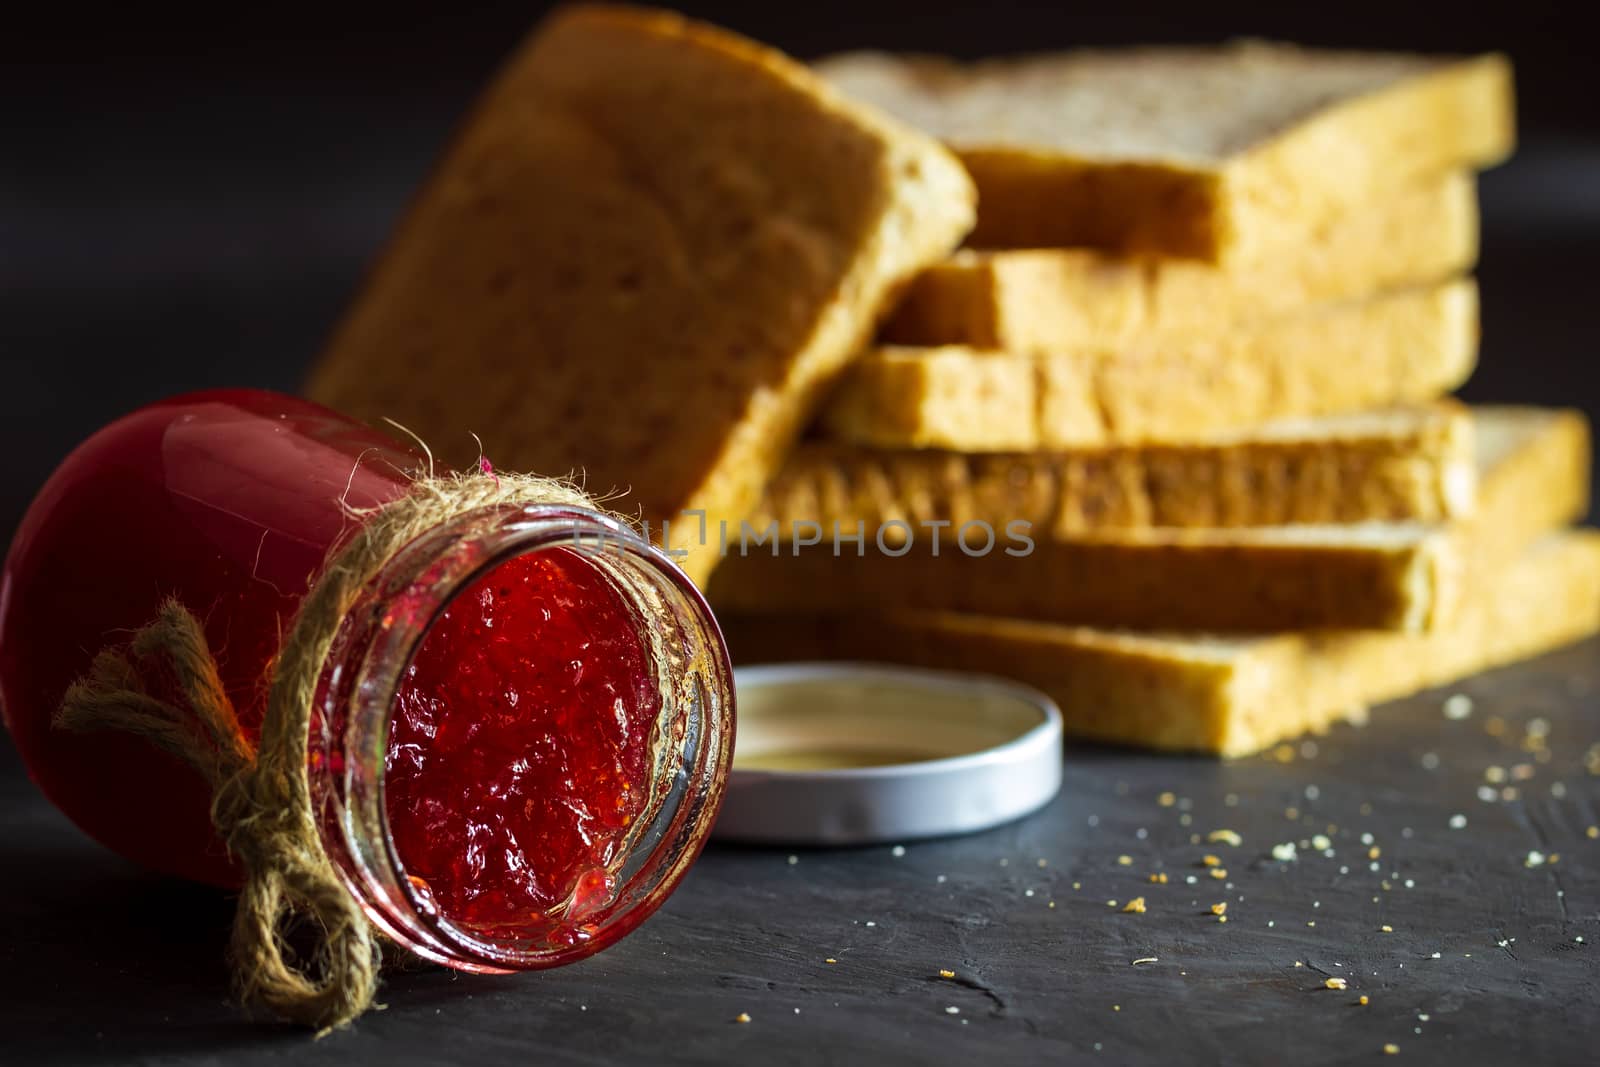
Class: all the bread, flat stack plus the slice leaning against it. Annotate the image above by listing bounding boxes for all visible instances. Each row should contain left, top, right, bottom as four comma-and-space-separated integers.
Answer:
309, 5, 1600, 753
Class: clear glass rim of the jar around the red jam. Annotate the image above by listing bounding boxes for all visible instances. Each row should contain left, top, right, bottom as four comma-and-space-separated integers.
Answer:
307, 506, 734, 971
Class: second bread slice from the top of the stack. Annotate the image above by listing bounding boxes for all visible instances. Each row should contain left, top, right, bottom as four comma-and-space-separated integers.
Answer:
878, 171, 1478, 352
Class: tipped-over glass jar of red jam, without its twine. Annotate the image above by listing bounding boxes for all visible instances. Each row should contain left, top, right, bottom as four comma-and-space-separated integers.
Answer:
0, 390, 733, 971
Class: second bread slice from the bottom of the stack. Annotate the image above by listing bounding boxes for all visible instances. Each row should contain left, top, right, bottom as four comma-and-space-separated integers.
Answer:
710, 410, 1589, 630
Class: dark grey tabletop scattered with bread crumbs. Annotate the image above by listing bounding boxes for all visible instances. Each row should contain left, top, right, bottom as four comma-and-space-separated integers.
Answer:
0, 641, 1600, 1064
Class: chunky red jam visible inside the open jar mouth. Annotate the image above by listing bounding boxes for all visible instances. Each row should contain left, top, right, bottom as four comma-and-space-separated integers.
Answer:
384, 549, 661, 944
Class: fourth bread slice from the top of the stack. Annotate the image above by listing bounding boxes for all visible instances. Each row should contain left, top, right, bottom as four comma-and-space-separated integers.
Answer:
750, 402, 1472, 537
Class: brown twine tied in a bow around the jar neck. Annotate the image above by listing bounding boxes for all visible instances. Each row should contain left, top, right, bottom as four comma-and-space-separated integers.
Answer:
54, 466, 595, 1032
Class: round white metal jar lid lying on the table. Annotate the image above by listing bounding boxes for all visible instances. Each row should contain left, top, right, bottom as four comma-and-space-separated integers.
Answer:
712, 662, 1062, 845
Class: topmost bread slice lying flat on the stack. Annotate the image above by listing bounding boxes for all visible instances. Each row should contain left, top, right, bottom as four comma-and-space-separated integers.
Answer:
819, 42, 1514, 262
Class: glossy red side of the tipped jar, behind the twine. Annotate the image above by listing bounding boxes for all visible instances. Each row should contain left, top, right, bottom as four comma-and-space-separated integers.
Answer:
0, 390, 416, 885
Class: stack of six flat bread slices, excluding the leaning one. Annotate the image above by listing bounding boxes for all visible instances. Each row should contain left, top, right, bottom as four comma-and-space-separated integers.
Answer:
710, 43, 1600, 755
